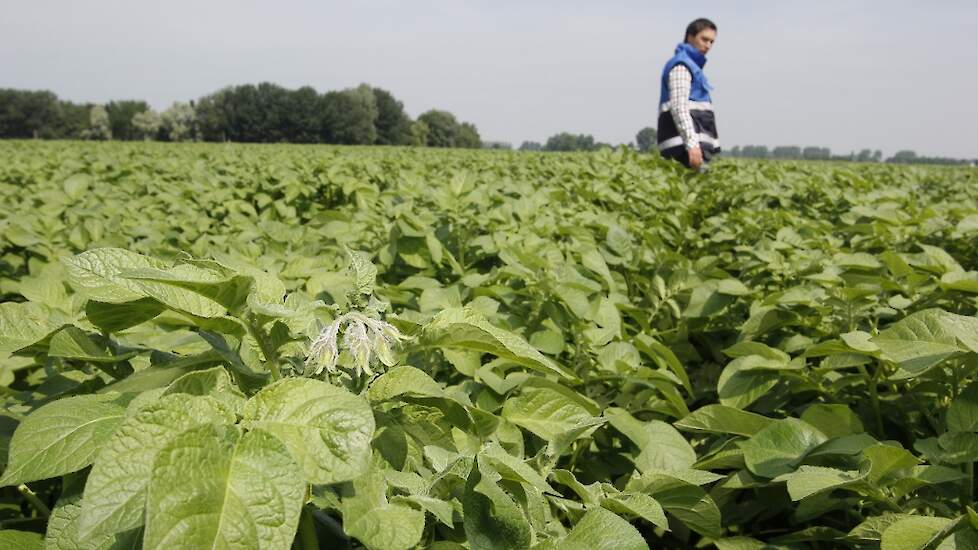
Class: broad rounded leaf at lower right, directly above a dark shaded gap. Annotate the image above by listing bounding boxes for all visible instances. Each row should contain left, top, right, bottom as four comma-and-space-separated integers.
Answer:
740, 418, 827, 478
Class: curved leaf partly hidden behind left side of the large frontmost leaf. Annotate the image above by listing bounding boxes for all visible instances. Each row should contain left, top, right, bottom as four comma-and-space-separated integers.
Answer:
78, 394, 234, 539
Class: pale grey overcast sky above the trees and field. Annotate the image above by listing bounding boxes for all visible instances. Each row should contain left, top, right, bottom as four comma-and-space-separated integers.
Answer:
0, 0, 978, 158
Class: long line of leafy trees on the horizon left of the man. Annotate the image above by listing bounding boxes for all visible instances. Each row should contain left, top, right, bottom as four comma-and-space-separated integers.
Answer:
0, 82, 482, 148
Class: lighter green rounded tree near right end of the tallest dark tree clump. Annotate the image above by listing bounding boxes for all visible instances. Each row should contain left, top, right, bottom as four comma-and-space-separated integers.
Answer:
322, 84, 379, 145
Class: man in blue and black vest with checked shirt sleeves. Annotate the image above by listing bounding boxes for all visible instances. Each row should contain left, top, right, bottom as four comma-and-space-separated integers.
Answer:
657, 19, 720, 170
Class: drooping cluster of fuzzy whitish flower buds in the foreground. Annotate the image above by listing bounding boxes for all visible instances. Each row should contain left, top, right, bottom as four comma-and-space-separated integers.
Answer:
306, 311, 409, 375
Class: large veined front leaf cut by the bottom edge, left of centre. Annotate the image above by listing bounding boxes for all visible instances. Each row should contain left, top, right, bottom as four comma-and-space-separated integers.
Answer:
144, 425, 306, 548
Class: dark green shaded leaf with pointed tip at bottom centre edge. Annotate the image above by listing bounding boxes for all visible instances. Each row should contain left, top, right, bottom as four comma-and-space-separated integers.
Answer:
462, 457, 528, 550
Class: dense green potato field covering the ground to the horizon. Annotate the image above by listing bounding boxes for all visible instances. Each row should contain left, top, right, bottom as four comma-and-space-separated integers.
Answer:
0, 142, 978, 550
